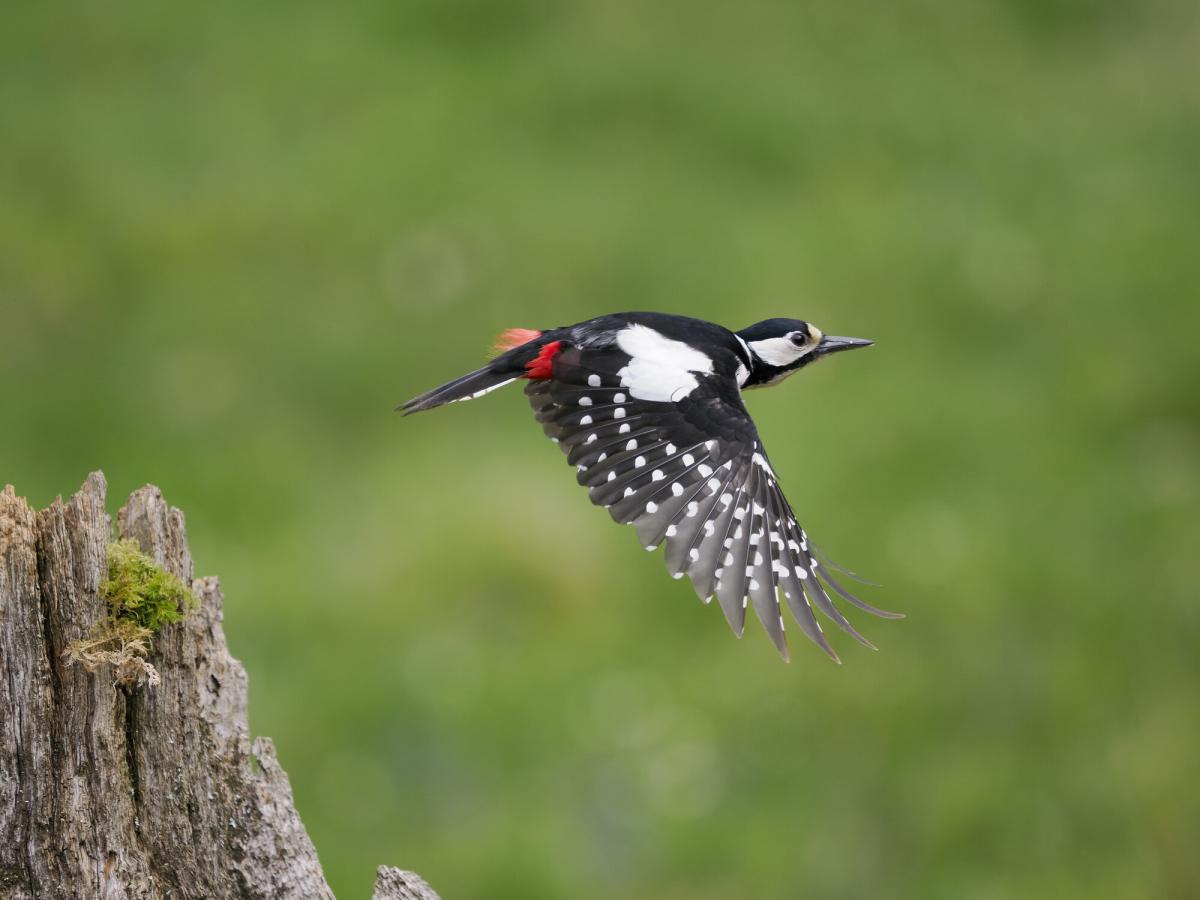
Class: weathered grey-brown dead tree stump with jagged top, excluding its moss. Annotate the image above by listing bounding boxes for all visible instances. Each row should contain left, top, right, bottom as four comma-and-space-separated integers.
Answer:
0, 473, 436, 900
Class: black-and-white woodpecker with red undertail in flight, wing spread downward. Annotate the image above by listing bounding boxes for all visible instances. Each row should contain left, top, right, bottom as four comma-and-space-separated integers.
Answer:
398, 312, 902, 662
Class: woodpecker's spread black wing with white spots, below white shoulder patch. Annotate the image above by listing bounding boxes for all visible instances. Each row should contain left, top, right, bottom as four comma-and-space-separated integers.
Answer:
526, 346, 898, 660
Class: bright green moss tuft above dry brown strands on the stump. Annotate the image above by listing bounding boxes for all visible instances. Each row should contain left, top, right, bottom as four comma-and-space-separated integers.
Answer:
100, 540, 199, 632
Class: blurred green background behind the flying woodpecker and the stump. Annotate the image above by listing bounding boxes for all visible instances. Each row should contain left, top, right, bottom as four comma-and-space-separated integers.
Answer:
0, 0, 1200, 900
